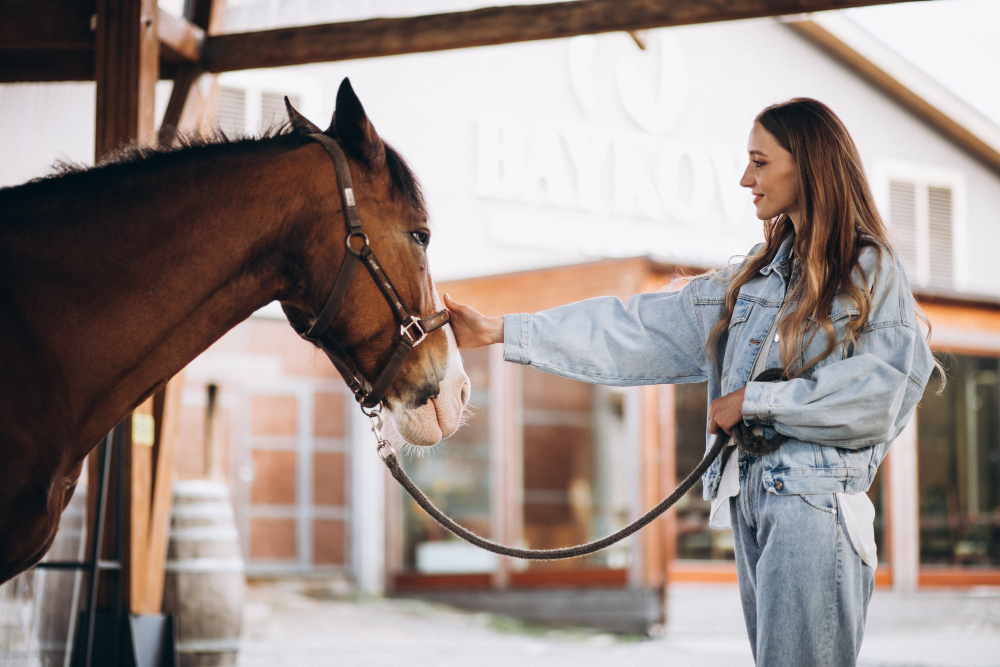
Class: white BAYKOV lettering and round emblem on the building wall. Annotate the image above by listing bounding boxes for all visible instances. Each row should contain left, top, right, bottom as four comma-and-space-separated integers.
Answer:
476, 30, 748, 255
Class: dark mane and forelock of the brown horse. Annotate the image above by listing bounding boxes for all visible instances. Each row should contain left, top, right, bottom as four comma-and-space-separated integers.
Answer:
0, 122, 426, 219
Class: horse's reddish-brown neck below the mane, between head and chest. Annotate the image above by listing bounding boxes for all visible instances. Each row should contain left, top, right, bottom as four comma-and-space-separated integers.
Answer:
0, 141, 331, 458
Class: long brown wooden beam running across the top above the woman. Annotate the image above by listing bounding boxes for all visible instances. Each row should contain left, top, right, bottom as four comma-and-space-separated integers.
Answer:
202, 0, 916, 72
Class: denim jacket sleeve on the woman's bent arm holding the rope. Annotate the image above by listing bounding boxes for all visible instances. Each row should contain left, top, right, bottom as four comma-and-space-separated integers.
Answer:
743, 251, 934, 449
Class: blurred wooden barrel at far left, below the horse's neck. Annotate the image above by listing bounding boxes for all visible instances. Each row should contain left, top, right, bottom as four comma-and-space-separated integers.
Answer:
33, 473, 87, 667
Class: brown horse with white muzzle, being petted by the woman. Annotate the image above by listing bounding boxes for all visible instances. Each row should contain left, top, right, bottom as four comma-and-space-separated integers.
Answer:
0, 79, 469, 582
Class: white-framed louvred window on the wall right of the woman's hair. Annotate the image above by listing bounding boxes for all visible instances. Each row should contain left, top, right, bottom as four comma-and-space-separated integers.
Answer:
881, 165, 964, 290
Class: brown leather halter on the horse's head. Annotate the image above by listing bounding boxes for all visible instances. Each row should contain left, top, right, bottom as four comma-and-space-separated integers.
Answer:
299, 134, 450, 409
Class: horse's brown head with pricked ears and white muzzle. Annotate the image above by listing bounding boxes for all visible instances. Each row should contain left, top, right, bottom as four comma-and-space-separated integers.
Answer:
282, 79, 470, 446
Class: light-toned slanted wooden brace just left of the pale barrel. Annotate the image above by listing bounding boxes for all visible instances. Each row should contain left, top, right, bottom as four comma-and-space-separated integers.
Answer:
132, 372, 184, 614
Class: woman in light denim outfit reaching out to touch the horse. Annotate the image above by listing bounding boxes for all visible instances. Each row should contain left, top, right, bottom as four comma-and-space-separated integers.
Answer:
445, 99, 934, 667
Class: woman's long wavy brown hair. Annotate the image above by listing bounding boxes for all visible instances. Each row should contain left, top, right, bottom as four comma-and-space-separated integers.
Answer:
708, 98, 892, 377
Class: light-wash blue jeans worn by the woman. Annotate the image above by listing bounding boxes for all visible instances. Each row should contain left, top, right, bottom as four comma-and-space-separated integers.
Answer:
730, 456, 875, 667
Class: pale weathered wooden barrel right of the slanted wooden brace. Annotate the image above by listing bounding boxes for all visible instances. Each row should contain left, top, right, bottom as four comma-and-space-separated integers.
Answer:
163, 480, 246, 667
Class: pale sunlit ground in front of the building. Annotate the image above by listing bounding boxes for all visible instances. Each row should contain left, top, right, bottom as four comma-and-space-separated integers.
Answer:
239, 581, 1000, 667
